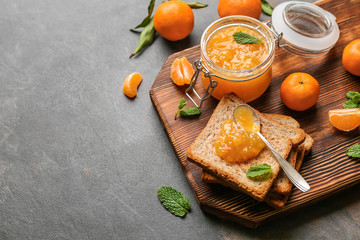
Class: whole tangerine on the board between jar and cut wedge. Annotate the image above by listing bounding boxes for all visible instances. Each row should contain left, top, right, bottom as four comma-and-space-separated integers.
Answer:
280, 72, 320, 111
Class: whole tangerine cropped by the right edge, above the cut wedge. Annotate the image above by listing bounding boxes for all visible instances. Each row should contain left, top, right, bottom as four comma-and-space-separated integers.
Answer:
342, 39, 360, 76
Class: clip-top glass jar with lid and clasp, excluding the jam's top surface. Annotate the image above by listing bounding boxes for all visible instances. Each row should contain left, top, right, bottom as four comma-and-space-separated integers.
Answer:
186, 1, 339, 108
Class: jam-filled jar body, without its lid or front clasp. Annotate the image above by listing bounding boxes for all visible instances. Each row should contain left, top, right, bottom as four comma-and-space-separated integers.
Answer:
201, 16, 275, 102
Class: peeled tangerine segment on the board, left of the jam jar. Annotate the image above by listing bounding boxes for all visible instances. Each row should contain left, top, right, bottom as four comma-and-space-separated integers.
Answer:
171, 57, 194, 86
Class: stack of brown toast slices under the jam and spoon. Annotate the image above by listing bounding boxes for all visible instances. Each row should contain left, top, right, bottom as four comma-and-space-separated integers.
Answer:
187, 94, 314, 208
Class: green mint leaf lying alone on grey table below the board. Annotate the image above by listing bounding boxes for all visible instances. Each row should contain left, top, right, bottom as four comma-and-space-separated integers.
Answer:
157, 186, 191, 217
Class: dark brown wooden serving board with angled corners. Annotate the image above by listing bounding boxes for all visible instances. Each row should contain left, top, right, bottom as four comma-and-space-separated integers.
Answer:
150, 0, 360, 228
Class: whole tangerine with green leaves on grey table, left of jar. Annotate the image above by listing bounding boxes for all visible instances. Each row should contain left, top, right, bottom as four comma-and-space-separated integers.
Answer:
154, 1, 194, 41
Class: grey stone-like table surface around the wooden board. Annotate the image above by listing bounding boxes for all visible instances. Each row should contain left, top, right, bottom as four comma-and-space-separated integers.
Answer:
0, 0, 360, 240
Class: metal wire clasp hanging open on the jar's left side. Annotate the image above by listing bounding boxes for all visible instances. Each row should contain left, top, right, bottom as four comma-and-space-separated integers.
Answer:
185, 60, 219, 108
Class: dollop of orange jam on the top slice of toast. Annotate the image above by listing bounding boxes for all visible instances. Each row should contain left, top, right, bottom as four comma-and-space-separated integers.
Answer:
214, 105, 265, 163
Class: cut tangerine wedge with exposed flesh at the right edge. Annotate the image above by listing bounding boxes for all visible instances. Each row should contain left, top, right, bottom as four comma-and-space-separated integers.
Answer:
329, 108, 360, 131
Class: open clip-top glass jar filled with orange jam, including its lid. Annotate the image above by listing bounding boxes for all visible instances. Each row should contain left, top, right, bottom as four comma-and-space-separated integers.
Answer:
186, 1, 339, 108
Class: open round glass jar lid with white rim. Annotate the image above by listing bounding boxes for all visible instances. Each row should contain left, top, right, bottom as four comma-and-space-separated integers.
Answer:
272, 1, 340, 57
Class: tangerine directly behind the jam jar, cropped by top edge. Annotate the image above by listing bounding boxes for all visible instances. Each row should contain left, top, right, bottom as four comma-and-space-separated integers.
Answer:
218, 0, 262, 19
